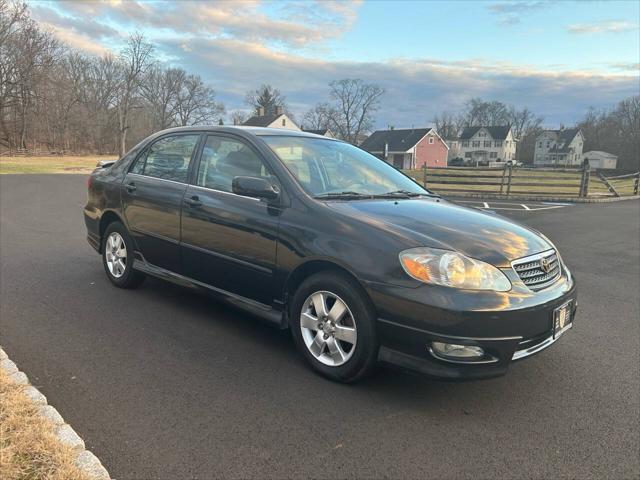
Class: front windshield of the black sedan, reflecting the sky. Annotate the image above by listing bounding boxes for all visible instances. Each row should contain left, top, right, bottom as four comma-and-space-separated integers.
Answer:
262, 135, 429, 197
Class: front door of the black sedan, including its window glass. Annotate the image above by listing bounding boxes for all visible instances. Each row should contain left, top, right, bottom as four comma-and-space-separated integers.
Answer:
181, 134, 281, 305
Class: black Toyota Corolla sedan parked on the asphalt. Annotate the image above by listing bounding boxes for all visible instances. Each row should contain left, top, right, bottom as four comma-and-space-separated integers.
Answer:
84, 127, 577, 382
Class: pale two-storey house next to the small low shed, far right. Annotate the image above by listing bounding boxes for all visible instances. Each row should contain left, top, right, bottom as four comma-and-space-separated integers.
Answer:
533, 127, 584, 166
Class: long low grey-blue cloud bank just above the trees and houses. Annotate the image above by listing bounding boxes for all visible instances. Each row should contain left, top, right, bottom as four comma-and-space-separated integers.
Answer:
156, 39, 640, 128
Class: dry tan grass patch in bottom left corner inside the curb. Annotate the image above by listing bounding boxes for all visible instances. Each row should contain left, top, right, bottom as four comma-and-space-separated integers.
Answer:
0, 369, 88, 480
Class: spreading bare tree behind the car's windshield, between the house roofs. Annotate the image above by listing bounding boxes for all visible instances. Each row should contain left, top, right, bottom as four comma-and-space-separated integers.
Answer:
329, 78, 384, 144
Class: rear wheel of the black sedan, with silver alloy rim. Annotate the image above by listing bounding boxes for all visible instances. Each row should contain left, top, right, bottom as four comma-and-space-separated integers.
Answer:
102, 222, 145, 288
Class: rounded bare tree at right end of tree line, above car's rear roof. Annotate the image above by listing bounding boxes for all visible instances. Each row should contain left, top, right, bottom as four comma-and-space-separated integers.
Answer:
176, 75, 225, 126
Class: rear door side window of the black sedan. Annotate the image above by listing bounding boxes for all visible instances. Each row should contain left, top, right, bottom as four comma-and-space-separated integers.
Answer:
131, 135, 200, 183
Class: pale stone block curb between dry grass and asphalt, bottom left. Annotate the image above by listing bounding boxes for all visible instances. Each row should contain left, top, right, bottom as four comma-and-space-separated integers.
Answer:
0, 347, 111, 480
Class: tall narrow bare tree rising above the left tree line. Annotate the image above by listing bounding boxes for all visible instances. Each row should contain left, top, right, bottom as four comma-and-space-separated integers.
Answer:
115, 33, 153, 156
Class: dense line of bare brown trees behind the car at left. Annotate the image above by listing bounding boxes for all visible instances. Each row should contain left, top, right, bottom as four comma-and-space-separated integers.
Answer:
0, 0, 225, 154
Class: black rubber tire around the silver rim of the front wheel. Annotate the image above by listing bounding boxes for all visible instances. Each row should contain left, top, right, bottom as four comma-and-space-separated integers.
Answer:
289, 271, 379, 383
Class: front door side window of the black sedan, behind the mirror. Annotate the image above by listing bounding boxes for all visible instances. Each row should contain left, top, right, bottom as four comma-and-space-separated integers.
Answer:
197, 135, 272, 192
